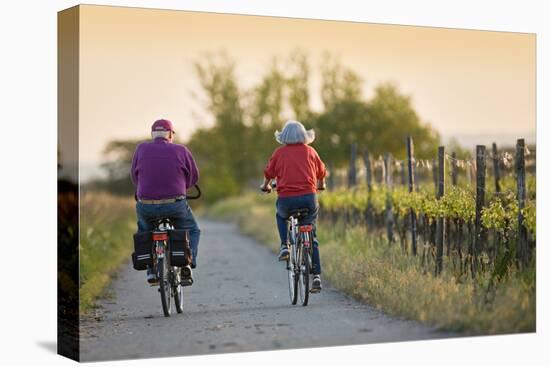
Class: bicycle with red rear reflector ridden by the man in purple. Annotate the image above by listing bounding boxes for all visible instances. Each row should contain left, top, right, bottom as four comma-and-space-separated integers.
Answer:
136, 185, 201, 317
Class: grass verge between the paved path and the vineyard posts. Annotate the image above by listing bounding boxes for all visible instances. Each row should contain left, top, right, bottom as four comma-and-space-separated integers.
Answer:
207, 194, 536, 335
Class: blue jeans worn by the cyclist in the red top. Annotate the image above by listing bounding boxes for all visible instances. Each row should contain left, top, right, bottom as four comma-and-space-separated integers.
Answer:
275, 194, 321, 274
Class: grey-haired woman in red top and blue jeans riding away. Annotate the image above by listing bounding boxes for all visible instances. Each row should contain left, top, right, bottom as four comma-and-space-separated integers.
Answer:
260, 120, 327, 292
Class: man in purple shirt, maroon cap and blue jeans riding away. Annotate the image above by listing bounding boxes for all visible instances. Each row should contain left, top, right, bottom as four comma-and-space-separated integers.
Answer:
131, 119, 200, 285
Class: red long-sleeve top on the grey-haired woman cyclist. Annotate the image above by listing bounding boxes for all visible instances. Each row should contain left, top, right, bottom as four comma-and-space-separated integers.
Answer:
264, 144, 327, 197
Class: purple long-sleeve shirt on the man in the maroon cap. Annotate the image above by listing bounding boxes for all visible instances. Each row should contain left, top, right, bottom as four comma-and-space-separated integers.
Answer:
131, 138, 199, 200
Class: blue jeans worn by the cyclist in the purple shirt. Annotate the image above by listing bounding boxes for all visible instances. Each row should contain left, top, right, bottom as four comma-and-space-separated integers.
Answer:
136, 199, 201, 267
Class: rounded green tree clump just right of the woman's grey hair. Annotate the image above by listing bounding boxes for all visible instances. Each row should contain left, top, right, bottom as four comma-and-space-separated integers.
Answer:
315, 79, 440, 167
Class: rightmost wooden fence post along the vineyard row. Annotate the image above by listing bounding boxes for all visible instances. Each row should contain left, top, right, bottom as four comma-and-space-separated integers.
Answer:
516, 139, 529, 267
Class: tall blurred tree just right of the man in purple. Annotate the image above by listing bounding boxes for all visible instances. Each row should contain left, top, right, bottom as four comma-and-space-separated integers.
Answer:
188, 53, 255, 201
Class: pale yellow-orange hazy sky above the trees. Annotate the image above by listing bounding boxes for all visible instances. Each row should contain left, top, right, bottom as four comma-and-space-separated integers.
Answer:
80, 6, 536, 179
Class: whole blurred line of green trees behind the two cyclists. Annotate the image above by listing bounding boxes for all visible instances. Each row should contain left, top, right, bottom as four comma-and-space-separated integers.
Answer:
90, 50, 440, 202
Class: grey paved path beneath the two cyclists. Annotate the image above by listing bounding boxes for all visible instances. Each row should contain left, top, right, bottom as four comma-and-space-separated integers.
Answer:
81, 221, 449, 361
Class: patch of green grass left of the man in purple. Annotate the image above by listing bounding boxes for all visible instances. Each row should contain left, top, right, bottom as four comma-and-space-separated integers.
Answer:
80, 193, 136, 312
